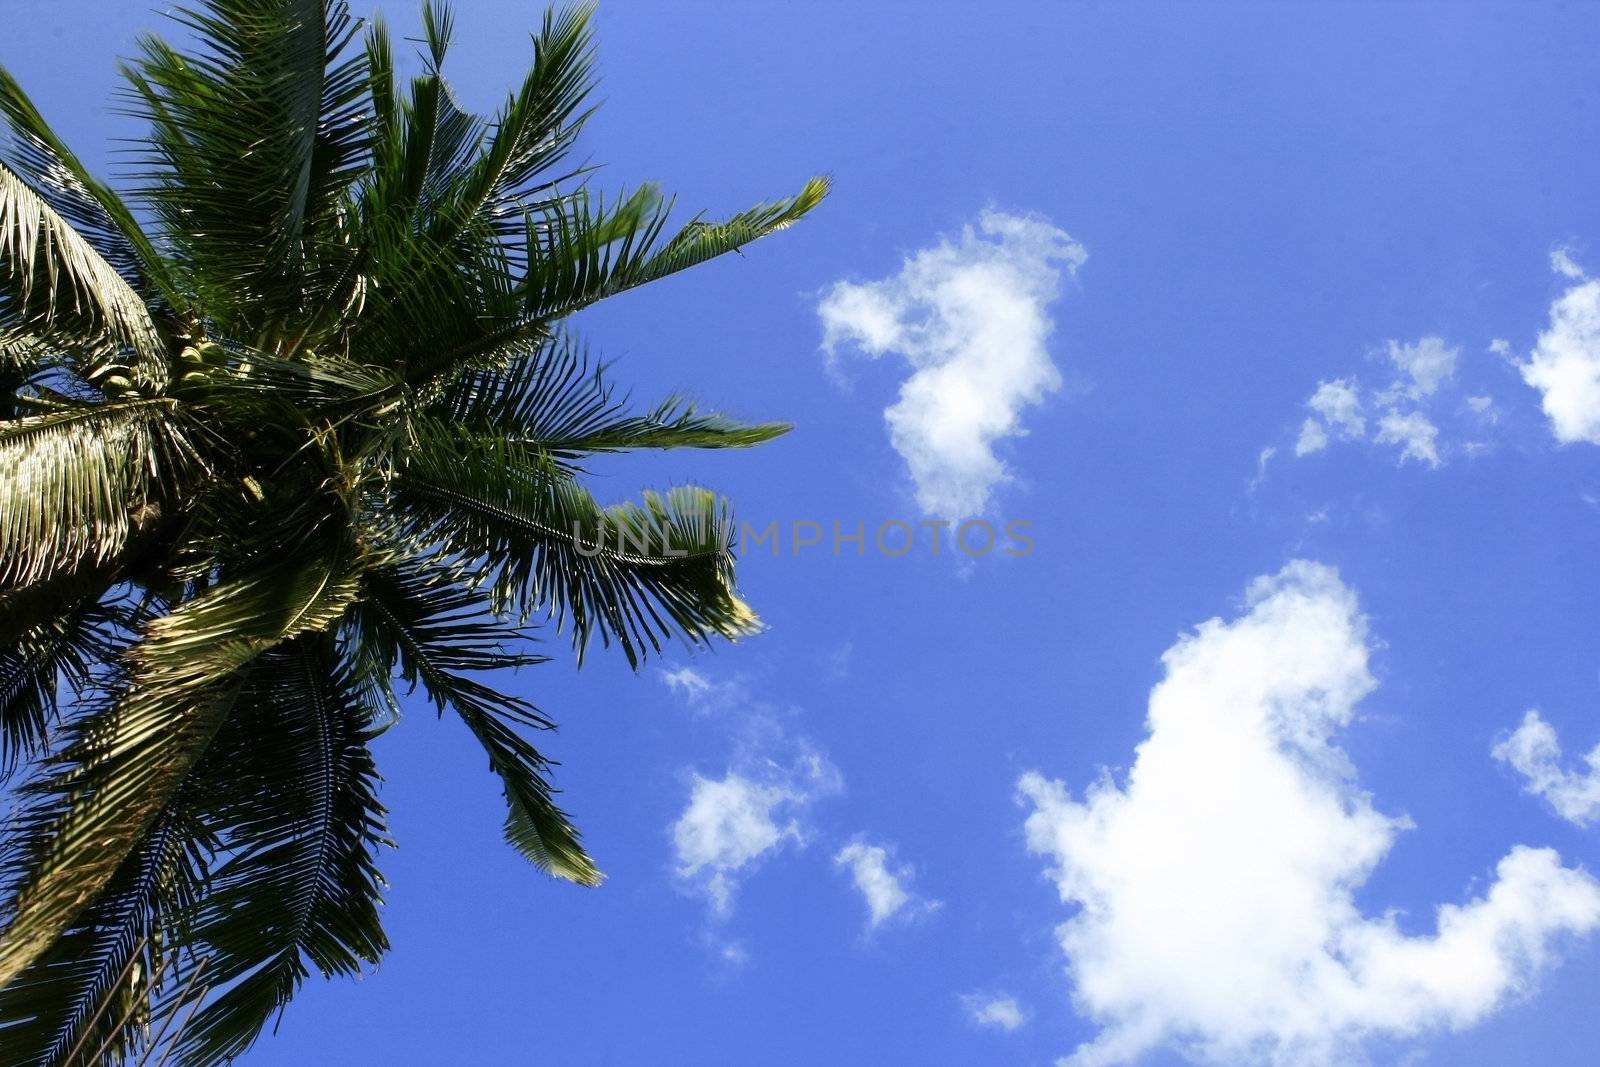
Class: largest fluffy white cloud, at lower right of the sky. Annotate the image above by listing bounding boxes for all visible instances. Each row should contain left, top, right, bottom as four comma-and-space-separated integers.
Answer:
1019, 561, 1600, 1067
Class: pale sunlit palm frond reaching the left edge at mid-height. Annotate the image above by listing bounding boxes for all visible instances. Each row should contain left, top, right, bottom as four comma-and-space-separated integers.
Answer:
0, 398, 200, 587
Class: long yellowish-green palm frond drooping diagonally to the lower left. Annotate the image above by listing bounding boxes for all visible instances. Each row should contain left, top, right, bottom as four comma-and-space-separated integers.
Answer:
0, 545, 358, 987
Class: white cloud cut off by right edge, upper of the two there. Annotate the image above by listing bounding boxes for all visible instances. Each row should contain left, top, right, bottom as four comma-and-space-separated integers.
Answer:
1518, 278, 1600, 445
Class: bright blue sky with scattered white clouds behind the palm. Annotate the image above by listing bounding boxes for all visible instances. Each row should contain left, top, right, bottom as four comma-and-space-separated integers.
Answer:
9, 0, 1600, 1067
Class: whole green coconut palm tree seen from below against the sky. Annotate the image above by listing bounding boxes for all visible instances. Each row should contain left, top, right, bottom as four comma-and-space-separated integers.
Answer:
0, 0, 826, 1065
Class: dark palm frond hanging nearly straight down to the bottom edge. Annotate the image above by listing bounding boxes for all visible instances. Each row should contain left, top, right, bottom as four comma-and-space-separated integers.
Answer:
163, 633, 389, 1064
